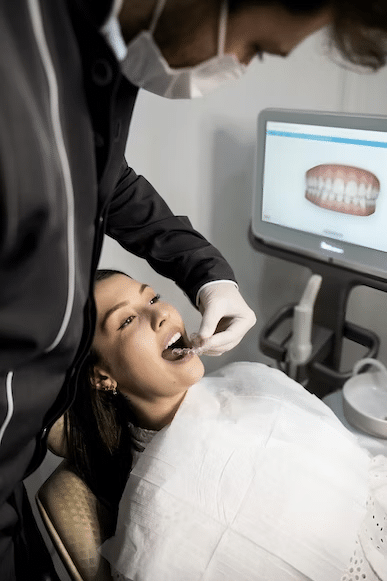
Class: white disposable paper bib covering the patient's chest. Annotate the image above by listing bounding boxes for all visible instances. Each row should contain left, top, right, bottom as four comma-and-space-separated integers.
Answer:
102, 363, 370, 581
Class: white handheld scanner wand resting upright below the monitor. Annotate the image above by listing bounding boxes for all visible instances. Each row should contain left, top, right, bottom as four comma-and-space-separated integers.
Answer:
288, 274, 322, 379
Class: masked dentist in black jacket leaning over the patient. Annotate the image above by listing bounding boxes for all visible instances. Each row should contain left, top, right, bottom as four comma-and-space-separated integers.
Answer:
0, 0, 381, 581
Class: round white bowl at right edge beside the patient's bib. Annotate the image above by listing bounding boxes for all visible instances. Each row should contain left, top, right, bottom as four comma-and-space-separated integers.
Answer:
343, 361, 387, 438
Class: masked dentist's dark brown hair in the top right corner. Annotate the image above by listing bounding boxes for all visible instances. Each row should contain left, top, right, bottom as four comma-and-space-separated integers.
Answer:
228, 0, 387, 70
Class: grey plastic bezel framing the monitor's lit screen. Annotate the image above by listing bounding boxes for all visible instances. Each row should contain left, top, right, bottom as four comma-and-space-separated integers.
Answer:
251, 109, 387, 279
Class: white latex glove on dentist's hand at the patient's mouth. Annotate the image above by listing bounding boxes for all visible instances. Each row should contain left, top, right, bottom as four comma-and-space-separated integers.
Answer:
193, 281, 257, 355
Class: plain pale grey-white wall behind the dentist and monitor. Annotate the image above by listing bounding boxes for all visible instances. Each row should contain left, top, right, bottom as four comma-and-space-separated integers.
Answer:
28, 27, 387, 579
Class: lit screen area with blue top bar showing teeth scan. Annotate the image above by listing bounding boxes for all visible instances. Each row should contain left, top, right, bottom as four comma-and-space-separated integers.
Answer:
256, 120, 387, 270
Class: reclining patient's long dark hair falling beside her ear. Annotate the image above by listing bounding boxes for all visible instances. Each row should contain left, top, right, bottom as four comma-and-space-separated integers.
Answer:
65, 270, 141, 510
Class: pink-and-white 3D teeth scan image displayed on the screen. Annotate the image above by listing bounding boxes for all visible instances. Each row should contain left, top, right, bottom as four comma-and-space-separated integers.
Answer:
305, 164, 380, 216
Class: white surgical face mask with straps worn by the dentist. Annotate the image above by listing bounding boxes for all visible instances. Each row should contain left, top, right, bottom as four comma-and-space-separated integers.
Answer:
121, 0, 246, 99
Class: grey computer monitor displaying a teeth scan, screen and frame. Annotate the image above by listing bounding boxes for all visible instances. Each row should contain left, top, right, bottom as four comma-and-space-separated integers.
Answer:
251, 109, 387, 279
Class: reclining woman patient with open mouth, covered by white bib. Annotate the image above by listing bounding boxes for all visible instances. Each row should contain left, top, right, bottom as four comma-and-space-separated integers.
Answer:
66, 271, 387, 581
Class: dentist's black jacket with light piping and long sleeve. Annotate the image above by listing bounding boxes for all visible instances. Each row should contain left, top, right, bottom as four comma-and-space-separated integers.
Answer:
0, 0, 234, 529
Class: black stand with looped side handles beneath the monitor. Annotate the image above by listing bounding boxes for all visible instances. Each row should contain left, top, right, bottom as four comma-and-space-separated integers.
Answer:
249, 228, 387, 397
